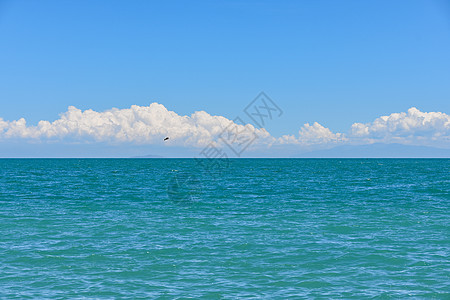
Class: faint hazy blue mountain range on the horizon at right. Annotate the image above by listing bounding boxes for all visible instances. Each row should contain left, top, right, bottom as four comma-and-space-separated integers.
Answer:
296, 143, 450, 158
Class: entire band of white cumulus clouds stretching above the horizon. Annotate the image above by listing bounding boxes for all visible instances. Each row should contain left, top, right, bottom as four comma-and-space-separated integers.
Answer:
0, 103, 450, 149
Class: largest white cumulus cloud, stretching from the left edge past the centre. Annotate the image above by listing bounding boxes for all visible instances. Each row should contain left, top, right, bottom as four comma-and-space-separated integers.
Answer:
0, 103, 270, 146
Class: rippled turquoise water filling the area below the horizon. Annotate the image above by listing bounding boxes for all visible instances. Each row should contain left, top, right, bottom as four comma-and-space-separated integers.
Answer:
0, 159, 450, 299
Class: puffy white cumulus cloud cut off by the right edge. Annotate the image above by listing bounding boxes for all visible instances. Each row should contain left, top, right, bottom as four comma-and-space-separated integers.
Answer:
350, 107, 450, 143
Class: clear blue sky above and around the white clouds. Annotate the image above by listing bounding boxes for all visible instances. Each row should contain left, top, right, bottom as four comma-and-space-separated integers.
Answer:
0, 0, 450, 156
